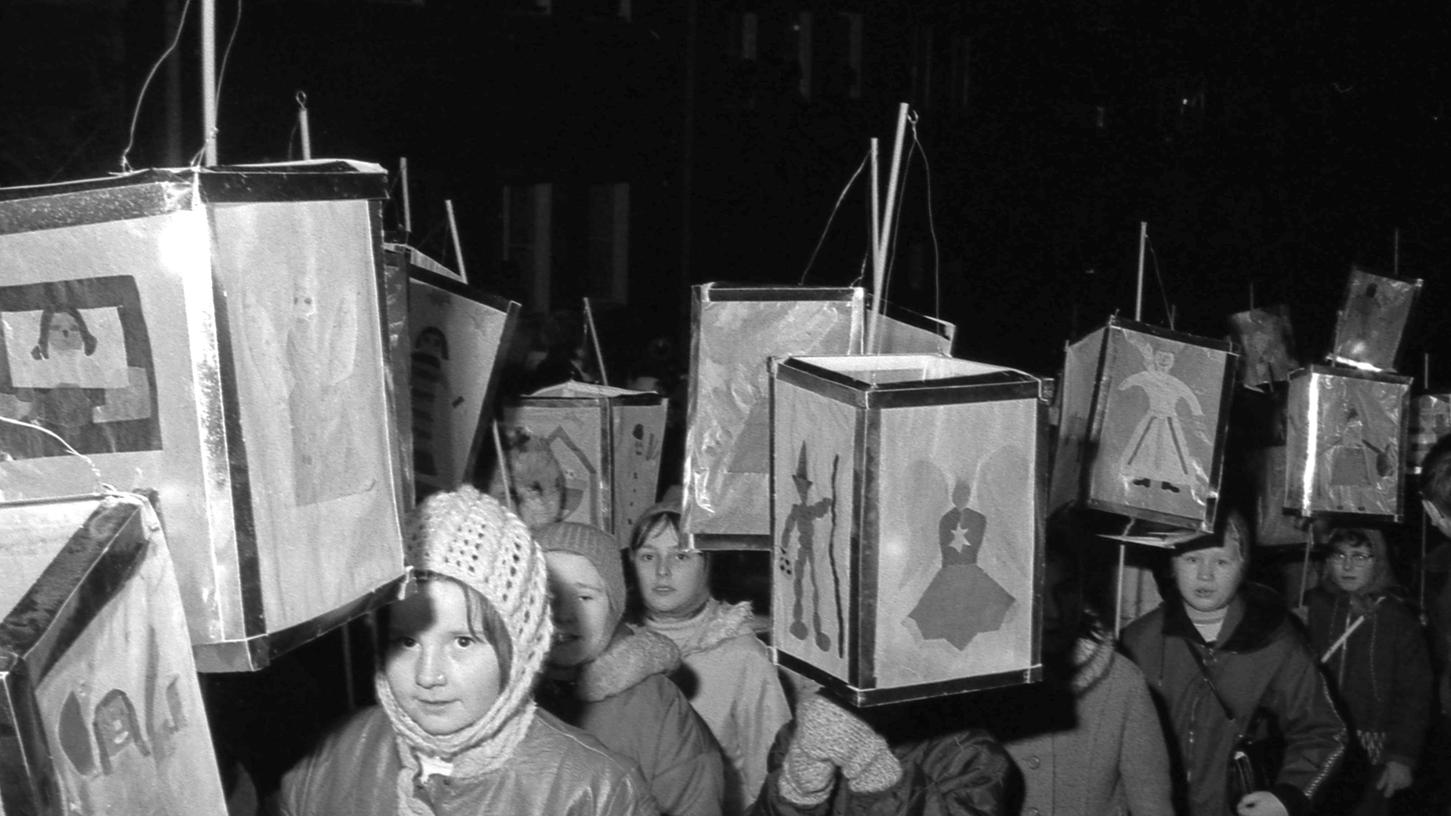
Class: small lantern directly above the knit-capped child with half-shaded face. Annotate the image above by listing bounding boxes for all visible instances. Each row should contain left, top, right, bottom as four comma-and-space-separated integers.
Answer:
502, 382, 667, 546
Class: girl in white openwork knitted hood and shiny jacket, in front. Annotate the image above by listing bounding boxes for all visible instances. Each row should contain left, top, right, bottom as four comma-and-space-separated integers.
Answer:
280, 485, 657, 816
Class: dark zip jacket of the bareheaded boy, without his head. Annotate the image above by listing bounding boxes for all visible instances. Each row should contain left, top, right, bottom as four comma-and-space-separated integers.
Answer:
1123, 584, 1347, 816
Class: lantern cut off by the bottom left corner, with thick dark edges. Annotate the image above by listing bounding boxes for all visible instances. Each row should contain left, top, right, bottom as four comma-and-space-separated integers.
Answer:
0, 494, 226, 816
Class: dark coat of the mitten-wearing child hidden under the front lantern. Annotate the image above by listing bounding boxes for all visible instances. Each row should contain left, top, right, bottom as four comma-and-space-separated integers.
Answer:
752, 722, 1008, 816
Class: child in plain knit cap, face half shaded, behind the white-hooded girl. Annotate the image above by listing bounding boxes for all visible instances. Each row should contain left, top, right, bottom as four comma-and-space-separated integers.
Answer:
534, 521, 723, 816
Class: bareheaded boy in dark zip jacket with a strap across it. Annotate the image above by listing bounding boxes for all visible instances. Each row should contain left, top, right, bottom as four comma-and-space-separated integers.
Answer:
1123, 507, 1347, 816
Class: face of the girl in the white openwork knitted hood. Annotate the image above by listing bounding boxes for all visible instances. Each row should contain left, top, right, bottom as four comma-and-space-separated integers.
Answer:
383, 581, 502, 736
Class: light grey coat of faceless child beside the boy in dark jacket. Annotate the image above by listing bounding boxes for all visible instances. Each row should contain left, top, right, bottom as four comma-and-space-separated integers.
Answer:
984, 637, 1174, 816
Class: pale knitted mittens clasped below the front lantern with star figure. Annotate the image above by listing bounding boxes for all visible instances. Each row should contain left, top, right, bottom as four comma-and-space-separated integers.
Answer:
779, 694, 903, 807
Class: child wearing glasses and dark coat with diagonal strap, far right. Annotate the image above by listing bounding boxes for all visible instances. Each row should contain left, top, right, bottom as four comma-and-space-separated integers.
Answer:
1309, 527, 1432, 815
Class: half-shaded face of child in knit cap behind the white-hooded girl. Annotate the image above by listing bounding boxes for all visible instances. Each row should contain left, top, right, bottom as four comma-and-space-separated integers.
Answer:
544, 552, 614, 666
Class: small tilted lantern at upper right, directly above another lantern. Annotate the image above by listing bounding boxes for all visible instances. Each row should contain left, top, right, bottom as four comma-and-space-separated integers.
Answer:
1329, 267, 1421, 372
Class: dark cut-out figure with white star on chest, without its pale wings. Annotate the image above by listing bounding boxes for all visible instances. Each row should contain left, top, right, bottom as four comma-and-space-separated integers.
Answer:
907, 479, 1014, 650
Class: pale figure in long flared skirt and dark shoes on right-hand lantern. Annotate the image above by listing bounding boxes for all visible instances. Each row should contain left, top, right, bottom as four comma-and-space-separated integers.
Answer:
1119, 343, 1204, 494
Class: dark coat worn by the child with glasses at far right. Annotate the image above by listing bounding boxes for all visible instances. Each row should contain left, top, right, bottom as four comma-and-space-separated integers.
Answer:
1307, 587, 1432, 768
